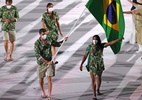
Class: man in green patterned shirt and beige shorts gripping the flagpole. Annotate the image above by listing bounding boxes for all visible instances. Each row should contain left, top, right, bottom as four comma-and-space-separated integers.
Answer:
34, 28, 68, 100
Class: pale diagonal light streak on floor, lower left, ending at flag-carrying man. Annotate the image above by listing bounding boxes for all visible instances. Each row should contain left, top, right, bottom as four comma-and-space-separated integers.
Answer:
0, 59, 36, 96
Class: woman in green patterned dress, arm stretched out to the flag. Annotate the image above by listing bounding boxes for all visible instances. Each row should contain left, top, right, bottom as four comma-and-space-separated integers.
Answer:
80, 35, 123, 100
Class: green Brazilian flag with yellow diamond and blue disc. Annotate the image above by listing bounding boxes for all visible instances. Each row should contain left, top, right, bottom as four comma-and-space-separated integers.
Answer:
86, 0, 125, 54
